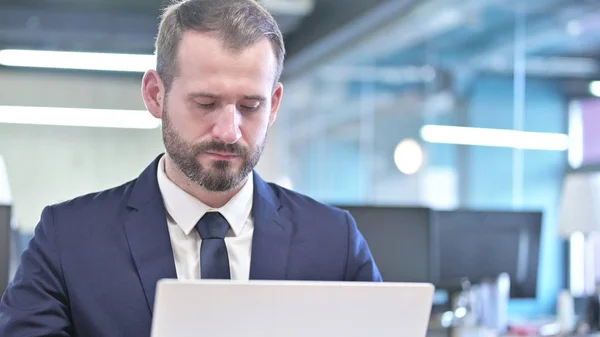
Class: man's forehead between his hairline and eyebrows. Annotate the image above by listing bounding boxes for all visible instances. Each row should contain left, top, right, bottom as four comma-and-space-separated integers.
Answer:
177, 31, 277, 88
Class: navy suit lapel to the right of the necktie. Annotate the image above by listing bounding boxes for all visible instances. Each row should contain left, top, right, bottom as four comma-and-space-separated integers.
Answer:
250, 173, 292, 280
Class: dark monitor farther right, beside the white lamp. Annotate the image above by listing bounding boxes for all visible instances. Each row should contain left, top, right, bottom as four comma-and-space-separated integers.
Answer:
432, 210, 542, 298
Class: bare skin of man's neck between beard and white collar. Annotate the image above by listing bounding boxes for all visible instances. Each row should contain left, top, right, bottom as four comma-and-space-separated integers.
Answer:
165, 155, 248, 208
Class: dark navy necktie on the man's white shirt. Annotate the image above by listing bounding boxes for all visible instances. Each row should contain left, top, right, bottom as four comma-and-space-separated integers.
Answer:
196, 212, 231, 280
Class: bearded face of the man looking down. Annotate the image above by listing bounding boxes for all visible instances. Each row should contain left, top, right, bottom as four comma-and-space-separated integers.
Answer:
162, 32, 282, 192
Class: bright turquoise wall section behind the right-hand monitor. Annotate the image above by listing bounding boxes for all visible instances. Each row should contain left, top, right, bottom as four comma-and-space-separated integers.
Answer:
464, 77, 567, 315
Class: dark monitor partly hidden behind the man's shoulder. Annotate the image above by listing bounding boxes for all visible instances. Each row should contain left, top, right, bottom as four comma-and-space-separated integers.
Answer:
337, 206, 437, 282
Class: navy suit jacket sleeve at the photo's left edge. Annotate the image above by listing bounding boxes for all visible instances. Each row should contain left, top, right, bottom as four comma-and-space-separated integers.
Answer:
0, 207, 73, 337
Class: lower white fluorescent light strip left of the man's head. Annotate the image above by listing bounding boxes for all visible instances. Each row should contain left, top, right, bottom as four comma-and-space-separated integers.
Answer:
0, 106, 160, 129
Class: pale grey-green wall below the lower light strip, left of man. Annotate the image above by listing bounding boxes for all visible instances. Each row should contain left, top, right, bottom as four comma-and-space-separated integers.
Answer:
0, 124, 162, 232
